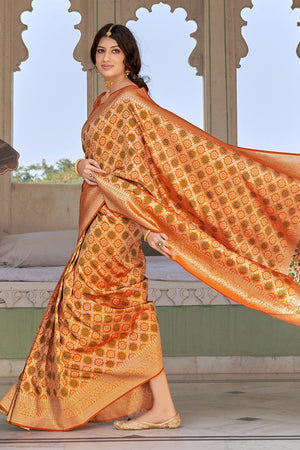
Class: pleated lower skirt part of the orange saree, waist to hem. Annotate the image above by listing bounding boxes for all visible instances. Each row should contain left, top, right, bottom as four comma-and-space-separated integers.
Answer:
1, 206, 163, 430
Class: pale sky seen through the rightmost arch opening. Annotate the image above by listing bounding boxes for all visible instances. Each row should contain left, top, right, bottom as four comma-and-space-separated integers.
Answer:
237, 0, 300, 153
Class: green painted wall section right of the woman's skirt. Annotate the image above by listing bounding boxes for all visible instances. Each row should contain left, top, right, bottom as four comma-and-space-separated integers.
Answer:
158, 305, 300, 356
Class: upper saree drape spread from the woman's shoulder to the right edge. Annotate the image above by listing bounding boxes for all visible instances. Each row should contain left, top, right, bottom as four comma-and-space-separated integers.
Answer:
80, 86, 300, 325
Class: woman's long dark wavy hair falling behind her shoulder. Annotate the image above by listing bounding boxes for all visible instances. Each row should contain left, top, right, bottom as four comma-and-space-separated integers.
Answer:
90, 23, 148, 91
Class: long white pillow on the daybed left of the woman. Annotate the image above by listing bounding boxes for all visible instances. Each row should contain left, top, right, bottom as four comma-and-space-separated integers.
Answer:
0, 230, 78, 267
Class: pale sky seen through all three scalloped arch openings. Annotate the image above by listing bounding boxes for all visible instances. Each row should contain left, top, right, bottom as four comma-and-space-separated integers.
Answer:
14, 0, 300, 166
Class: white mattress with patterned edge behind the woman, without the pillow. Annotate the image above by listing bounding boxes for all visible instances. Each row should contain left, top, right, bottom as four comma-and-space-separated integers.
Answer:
0, 256, 234, 308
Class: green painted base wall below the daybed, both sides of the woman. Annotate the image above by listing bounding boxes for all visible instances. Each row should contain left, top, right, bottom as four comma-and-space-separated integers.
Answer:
0, 305, 300, 359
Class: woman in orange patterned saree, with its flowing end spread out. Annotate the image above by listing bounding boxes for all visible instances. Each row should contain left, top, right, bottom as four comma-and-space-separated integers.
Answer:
0, 24, 300, 430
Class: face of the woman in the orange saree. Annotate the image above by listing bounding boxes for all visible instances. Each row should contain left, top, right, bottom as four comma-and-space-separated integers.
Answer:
96, 37, 125, 81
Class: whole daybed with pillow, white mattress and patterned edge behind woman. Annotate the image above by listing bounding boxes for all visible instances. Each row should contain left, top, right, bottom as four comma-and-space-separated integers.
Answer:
0, 230, 235, 308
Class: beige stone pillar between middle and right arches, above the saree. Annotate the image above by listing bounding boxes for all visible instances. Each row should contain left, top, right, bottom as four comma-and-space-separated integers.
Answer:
204, 0, 253, 144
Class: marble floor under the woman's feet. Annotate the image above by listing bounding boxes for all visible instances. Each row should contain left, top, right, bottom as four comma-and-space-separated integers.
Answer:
0, 374, 300, 450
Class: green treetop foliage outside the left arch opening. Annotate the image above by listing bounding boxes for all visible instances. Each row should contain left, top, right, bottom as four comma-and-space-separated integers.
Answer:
13, 158, 81, 183
